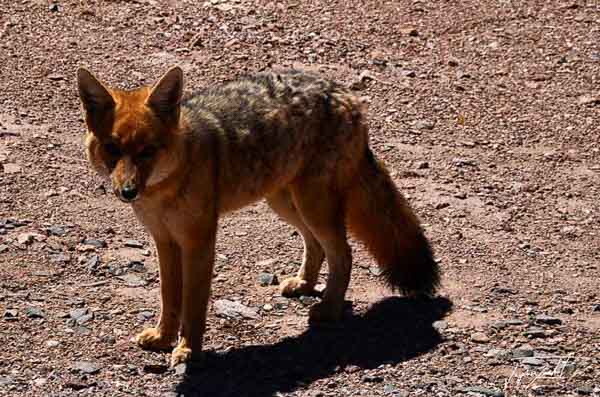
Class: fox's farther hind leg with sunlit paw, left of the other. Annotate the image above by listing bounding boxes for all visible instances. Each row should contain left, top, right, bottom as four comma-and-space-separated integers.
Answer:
267, 189, 325, 297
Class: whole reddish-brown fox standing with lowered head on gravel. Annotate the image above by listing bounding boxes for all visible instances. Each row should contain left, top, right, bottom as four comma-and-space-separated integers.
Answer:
77, 66, 441, 366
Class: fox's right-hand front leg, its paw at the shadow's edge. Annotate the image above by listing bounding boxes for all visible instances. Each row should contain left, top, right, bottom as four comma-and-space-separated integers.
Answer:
171, 225, 216, 366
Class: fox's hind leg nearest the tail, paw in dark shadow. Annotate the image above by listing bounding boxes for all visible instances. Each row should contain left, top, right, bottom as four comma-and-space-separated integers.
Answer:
292, 176, 352, 323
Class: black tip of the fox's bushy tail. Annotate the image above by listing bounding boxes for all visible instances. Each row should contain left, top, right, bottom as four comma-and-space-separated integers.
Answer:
383, 234, 441, 297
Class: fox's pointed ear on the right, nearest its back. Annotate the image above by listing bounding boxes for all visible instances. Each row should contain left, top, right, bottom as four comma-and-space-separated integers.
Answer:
146, 66, 183, 121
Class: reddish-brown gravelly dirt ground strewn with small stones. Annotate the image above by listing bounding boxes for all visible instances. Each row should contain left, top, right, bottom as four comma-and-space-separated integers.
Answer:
0, 0, 600, 397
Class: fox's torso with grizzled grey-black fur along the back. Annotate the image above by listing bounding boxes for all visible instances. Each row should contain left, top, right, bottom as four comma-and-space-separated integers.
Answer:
182, 71, 367, 213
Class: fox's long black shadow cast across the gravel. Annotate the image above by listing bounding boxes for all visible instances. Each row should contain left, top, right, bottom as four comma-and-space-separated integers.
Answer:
175, 297, 452, 397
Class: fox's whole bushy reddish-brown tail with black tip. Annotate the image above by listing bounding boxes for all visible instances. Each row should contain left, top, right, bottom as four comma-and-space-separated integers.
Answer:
346, 148, 440, 296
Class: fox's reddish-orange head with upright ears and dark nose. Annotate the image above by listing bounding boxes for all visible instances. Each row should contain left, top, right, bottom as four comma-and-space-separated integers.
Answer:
77, 67, 183, 202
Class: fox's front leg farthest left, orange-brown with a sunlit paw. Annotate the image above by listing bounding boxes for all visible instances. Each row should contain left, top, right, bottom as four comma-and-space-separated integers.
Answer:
135, 238, 182, 350
